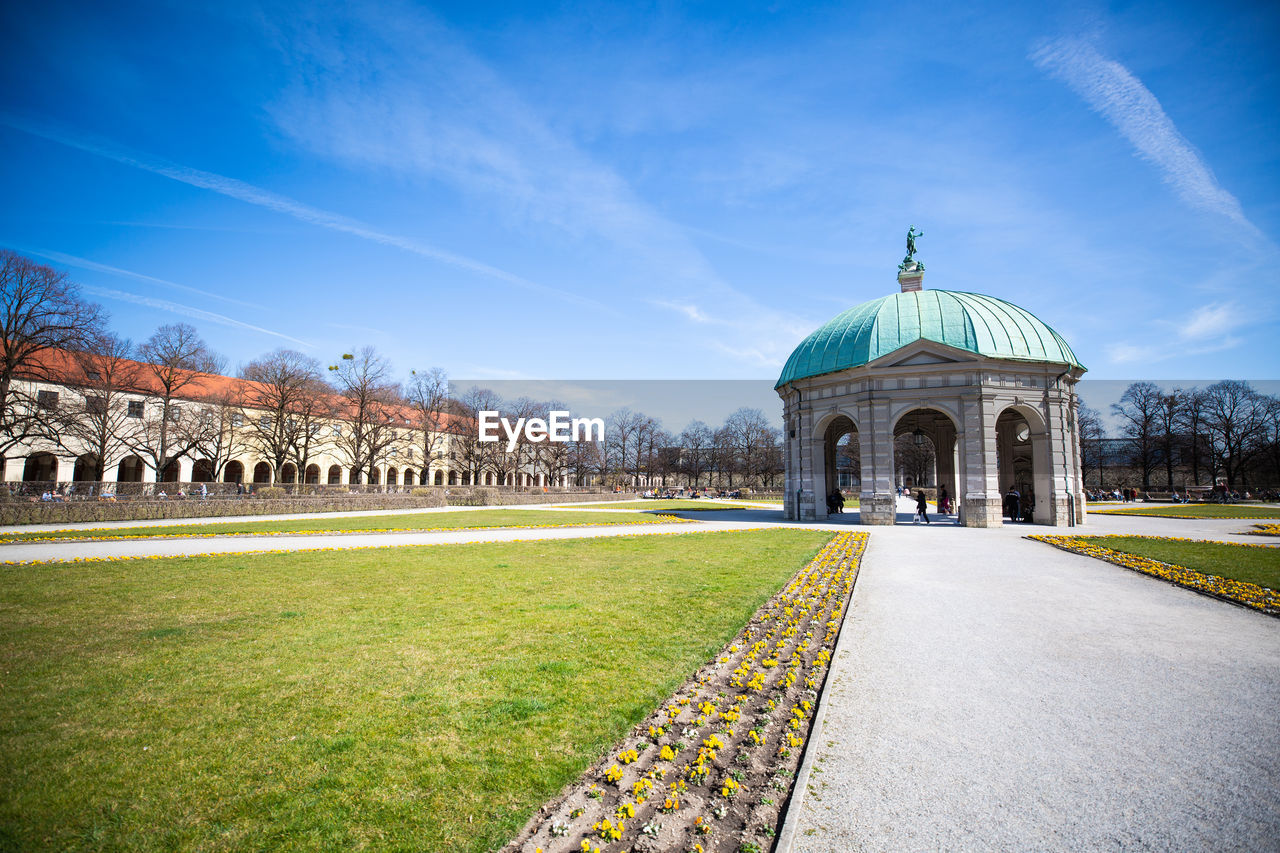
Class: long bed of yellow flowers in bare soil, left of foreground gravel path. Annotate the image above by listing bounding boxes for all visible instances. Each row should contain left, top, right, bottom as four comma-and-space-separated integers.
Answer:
504, 533, 867, 853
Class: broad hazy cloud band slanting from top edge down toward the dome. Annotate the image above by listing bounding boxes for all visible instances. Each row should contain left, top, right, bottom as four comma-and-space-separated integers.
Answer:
262, 5, 796, 364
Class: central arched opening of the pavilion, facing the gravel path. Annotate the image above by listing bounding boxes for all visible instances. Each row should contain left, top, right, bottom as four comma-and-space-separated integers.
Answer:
893, 409, 960, 521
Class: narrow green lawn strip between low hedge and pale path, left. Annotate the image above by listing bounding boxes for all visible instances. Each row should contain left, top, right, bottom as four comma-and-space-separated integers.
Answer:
0, 510, 680, 542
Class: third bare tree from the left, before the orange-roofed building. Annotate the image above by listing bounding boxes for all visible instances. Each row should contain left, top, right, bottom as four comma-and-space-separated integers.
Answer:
125, 323, 223, 483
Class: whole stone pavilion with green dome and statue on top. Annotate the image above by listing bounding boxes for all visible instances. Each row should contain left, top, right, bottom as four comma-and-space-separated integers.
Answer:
776, 234, 1085, 528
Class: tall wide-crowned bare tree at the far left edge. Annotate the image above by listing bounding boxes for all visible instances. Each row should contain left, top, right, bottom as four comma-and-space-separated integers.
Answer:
0, 250, 106, 476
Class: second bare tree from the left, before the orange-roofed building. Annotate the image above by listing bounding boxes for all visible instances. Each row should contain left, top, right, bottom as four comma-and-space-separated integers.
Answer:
59, 334, 140, 480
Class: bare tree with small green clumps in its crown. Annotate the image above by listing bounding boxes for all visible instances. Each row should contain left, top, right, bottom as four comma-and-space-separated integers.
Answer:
329, 347, 403, 482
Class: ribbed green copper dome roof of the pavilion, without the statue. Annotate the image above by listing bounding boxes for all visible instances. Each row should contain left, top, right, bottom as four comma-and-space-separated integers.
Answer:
774, 291, 1084, 388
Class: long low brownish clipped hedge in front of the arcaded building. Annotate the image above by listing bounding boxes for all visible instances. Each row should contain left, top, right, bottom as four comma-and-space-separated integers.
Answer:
0, 488, 619, 526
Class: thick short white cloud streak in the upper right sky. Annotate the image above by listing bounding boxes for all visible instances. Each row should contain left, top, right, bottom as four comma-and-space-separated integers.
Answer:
1030, 38, 1263, 240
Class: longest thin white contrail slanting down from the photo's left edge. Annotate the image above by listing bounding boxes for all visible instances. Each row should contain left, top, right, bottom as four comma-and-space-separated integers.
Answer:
0, 114, 604, 309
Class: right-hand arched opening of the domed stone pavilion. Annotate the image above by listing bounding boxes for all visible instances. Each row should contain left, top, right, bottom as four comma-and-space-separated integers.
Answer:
996, 406, 1053, 524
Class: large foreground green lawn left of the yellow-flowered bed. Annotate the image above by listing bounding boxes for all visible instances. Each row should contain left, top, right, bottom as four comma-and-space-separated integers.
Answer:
0, 530, 829, 852
